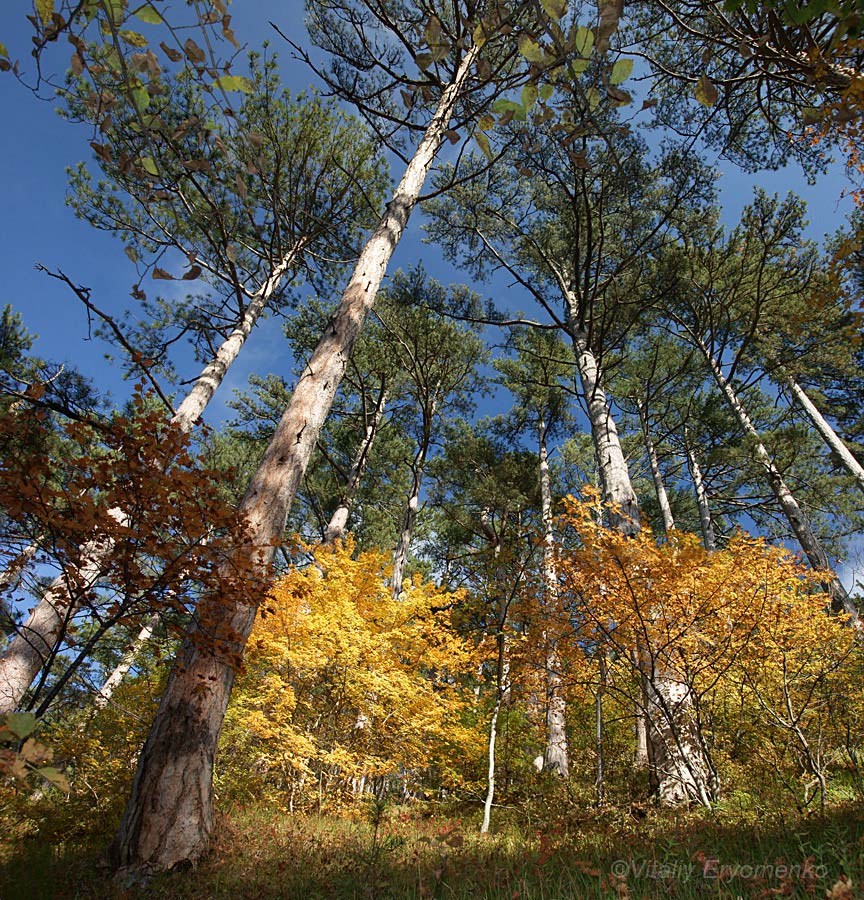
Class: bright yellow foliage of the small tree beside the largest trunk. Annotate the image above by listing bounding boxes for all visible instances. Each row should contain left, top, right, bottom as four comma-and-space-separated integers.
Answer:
218, 539, 482, 794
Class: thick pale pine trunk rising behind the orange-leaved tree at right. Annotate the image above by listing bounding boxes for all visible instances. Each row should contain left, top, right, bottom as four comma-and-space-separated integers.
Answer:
571, 326, 711, 805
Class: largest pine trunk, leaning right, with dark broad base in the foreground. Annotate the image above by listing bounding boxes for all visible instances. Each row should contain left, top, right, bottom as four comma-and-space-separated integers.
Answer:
111, 47, 478, 872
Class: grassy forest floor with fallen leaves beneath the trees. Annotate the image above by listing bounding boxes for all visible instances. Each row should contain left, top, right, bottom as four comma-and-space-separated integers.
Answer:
0, 804, 864, 900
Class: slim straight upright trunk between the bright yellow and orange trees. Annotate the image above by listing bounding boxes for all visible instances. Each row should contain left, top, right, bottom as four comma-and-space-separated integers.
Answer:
537, 418, 570, 778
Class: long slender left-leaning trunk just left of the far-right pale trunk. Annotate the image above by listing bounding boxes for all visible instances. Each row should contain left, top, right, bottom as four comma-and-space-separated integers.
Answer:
696, 337, 858, 626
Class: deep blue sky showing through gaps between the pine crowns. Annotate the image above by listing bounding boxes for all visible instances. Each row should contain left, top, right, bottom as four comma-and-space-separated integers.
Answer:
0, 0, 849, 422
